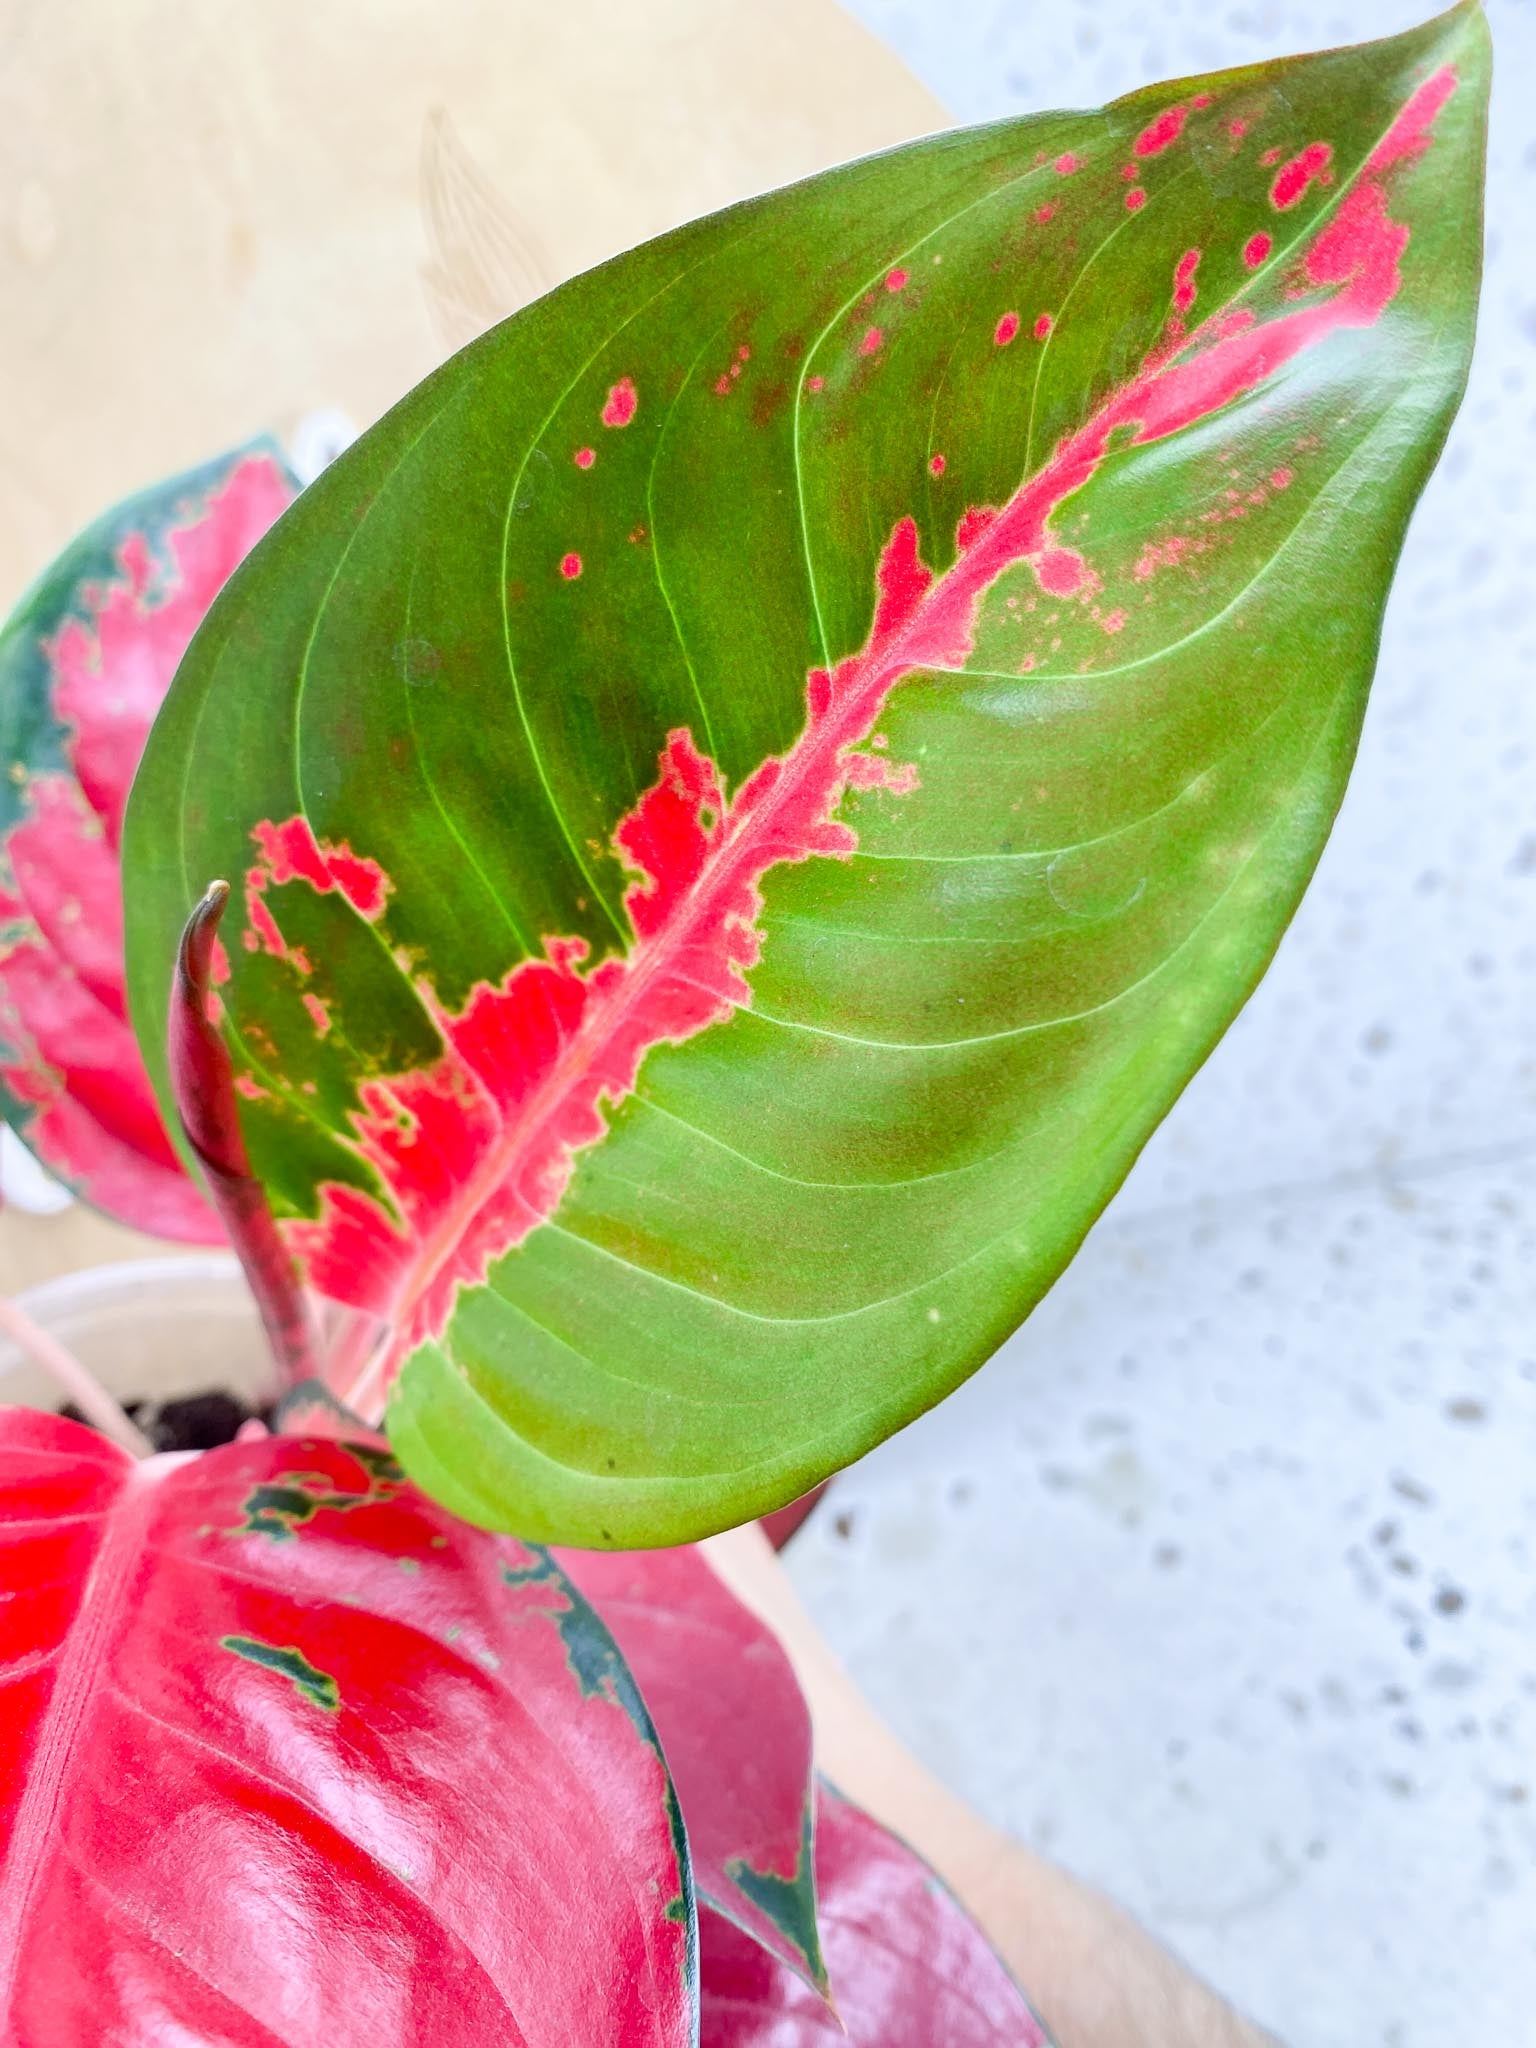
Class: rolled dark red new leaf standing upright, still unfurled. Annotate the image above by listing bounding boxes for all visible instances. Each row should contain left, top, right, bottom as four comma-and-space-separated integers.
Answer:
170, 883, 317, 1386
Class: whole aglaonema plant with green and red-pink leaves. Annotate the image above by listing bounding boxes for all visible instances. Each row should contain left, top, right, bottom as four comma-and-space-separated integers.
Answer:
0, 6, 1487, 2048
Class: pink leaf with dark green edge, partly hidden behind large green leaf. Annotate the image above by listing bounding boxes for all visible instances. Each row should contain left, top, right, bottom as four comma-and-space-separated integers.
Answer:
0, 446, 293, 1243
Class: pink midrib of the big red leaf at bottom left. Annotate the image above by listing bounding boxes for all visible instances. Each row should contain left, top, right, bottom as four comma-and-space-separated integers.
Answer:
0, 1458, 151, 2028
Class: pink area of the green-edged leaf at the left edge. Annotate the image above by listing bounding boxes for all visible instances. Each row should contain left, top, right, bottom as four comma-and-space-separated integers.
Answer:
0, 455, 291, 1243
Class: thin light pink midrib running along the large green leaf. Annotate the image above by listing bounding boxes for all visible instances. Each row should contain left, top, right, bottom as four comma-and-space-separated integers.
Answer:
352, 79, 1454, 1401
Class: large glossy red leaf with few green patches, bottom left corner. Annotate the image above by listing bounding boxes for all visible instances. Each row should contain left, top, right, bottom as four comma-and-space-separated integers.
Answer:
0, 1409, 694, 2048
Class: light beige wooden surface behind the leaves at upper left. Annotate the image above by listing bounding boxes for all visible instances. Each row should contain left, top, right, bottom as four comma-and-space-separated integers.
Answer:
0, 0, 944, 608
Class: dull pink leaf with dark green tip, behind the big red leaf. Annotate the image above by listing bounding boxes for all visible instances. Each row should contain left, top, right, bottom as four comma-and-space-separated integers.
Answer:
555, 1546, 825, 1989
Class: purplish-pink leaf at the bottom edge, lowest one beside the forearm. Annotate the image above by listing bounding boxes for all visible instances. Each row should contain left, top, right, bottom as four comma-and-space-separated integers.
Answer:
698, 1784, 1049, 2048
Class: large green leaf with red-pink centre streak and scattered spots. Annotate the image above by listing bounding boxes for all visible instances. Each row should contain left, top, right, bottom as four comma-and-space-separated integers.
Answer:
129, 8, 1487, 1544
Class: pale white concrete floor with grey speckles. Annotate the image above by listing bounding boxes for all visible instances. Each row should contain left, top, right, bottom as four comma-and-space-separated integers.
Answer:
793, 0, 1536, 2048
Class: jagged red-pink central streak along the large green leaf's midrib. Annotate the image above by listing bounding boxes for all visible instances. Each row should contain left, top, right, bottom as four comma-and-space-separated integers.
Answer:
259, 72, 1450, 1409
